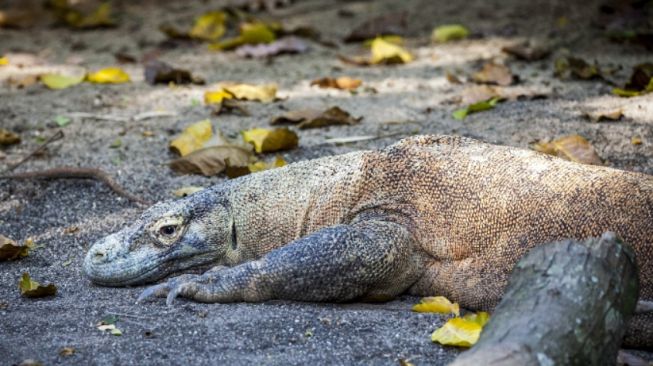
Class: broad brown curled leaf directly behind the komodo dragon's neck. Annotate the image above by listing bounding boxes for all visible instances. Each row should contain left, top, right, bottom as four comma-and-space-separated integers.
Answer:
170, 145, 252, 177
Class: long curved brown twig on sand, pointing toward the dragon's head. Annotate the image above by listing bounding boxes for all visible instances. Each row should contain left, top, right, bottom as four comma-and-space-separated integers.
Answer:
0, 167, 150, 205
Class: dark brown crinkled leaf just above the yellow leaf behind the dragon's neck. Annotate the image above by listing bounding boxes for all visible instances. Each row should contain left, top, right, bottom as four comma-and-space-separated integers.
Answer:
270, 107, 363, 129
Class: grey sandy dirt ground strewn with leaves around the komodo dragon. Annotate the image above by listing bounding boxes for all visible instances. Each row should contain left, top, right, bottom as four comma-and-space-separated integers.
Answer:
0, 0, 653, 365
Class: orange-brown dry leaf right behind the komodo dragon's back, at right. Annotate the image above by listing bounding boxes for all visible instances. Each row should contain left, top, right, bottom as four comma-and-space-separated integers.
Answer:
532, 135, 603, 165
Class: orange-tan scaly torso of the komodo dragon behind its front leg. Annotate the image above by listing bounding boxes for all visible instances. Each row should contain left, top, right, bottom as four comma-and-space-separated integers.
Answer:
362, 136, 653, 309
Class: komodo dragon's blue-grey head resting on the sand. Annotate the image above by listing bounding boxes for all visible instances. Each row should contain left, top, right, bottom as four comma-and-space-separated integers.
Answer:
84, 189, 235, 286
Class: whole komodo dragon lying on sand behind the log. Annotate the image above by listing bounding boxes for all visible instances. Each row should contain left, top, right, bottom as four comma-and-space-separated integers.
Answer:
84, 136, 653, 347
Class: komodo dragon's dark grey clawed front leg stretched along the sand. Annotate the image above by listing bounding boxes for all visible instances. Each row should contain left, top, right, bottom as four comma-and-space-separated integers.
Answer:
138, 220, 423, 305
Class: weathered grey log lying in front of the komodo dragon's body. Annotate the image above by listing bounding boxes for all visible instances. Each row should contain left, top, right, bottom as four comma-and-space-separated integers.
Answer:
452, 233, 639, 366
